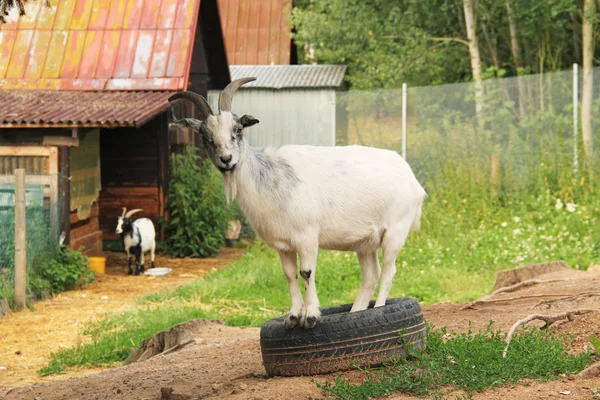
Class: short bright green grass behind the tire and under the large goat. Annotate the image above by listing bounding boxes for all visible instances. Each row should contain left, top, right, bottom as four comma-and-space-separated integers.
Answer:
40, 192, 600, 375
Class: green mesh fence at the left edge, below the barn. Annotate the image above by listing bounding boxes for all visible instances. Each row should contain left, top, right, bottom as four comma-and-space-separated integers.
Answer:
0, 175, 62, 305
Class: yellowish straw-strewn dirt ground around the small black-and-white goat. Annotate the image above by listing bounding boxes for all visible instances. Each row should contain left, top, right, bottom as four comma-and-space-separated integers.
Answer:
0, 248, 243, 388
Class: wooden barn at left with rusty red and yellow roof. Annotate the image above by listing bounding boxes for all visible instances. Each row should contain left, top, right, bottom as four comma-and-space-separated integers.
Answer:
0, 0, 230, 254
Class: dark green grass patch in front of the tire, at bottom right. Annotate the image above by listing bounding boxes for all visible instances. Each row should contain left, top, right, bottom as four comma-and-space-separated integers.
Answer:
318, 327, 592, 400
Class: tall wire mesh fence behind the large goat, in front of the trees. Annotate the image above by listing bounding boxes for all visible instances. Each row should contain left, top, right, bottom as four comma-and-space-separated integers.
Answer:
338, 68, 600, 198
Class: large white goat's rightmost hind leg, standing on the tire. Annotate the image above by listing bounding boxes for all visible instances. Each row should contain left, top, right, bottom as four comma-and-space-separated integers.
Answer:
375, 225, 412, 307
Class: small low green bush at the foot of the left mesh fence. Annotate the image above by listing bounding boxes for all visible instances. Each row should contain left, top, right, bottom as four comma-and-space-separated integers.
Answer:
39, 247, 94, 293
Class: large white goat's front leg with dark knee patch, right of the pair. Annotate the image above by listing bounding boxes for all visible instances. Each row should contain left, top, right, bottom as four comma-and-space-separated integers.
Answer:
298, 243, 321, 328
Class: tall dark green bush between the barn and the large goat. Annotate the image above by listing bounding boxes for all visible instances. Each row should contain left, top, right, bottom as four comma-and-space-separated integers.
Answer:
162, 145, 229, 257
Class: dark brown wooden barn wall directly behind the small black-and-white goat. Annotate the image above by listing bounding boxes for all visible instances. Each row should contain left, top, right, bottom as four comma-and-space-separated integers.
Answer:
99, 113, 169, 241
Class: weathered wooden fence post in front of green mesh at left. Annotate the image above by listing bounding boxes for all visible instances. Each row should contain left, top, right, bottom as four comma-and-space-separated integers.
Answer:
15, 168, 27, 308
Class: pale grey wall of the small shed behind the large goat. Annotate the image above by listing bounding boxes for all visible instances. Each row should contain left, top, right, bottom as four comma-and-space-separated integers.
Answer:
208, 89, 336, 147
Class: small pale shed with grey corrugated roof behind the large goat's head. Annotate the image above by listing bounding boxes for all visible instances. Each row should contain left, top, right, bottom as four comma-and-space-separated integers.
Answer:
208, 65, 347, 147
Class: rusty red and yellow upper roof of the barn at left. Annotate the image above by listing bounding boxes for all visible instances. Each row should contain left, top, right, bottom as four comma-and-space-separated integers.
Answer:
0, 0, 200, 90
